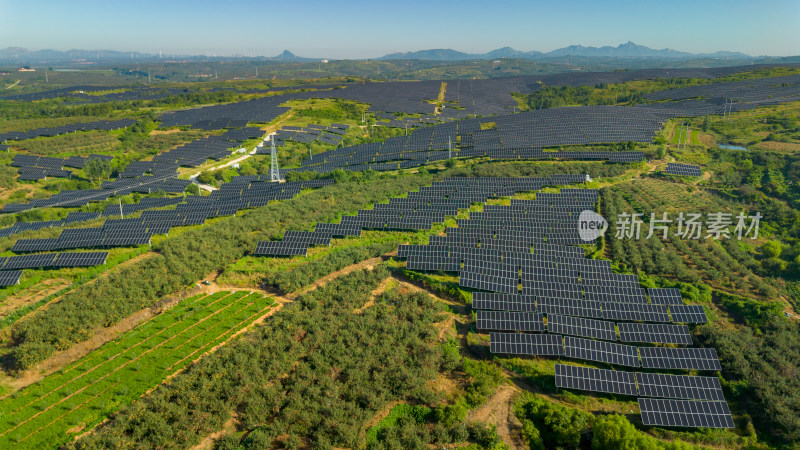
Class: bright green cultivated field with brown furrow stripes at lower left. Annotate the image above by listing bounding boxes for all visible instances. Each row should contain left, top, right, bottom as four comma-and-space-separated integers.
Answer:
0, 292, 273, 448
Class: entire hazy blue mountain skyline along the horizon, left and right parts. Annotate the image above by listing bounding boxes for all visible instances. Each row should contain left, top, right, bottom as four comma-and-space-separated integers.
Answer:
0, 42, 756, 65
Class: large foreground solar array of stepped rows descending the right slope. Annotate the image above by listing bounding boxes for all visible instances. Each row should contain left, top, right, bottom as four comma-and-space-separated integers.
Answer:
384, 188, 736, 428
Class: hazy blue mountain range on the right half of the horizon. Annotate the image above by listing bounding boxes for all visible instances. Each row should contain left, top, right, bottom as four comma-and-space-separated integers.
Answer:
378, 41, 753, 61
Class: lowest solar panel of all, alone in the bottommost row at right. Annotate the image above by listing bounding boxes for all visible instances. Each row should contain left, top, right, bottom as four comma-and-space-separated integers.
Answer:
638, 398, 734, 428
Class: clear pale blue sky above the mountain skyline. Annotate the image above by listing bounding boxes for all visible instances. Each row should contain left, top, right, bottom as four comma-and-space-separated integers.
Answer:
0, 0, 800, 58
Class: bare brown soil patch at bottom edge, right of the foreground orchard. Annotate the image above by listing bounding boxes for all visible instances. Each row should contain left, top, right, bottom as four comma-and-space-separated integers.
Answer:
467, 384, 526, 449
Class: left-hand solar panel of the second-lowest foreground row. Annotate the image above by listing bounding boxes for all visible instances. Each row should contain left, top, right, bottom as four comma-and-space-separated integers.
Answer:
556, 364, 636, 395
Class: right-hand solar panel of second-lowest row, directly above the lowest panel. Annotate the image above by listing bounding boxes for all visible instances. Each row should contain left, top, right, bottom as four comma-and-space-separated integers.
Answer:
636, 373, 725, 400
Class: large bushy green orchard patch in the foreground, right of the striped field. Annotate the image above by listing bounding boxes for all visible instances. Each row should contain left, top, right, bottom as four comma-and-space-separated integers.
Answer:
75, 266, 443, 449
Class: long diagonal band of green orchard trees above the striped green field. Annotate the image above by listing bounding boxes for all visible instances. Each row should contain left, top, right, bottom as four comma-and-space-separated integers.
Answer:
7, 175, 431, 369
